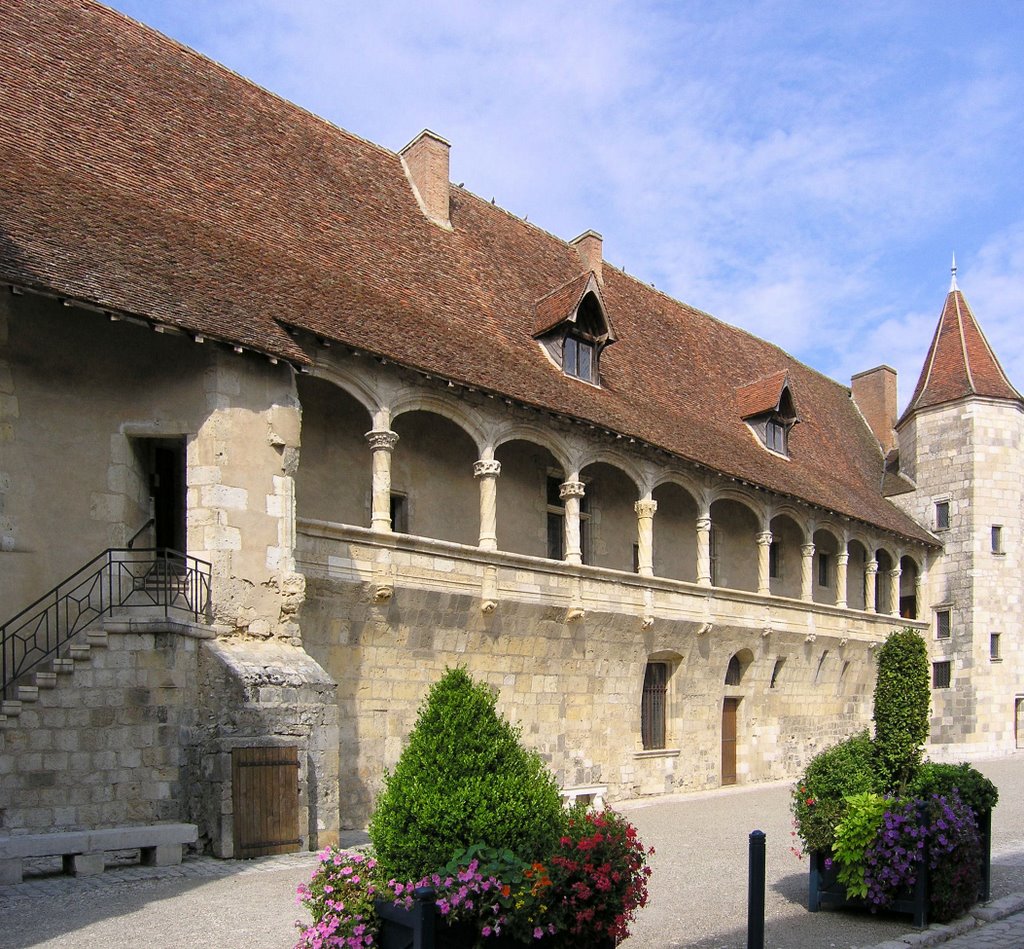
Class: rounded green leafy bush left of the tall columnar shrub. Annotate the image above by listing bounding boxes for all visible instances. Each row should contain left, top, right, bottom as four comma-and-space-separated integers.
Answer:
793, 731, 881, 854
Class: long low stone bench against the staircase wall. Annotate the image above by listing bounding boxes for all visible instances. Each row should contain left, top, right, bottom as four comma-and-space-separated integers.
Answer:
0, 824, 199, 883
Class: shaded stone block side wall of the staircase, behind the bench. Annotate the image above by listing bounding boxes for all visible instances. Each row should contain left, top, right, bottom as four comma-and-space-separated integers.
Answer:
0, 622, 203, 833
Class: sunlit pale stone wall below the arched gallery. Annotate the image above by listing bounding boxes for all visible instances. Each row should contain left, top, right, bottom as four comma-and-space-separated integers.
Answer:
298, 522, 903, 827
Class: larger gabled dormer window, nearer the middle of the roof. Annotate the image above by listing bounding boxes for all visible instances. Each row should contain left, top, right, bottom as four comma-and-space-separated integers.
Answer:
534, 271, 615, 386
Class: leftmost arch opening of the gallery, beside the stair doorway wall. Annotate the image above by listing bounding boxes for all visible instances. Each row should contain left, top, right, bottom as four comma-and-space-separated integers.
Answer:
295, 375, 377, 527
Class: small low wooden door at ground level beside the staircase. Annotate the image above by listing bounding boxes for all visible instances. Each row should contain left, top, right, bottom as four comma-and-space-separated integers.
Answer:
231, 745, 302, 858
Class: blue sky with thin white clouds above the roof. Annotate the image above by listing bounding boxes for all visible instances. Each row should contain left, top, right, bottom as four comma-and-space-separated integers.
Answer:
105, 0, 1024, 405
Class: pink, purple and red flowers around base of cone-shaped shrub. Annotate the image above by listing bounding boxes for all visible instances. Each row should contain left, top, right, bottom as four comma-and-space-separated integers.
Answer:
298, 810, 653, 949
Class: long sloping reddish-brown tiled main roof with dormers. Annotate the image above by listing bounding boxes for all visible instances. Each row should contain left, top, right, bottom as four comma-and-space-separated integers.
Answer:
0, 0, 931, 543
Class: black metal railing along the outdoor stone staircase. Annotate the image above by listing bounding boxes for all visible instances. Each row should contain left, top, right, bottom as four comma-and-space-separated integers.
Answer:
0, 548, 211, 698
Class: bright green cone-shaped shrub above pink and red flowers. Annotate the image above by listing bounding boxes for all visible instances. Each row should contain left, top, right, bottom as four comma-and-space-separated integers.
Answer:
370, 668, 566, 879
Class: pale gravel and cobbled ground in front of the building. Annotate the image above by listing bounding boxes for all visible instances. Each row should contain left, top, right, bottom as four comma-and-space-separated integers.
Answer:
0, 754, 1024, 949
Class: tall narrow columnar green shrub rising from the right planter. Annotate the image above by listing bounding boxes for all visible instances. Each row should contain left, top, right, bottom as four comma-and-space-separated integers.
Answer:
874, 629, 931, 794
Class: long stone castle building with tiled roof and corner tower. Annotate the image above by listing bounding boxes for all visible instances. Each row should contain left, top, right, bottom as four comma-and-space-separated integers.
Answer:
0, 0, 1024, 856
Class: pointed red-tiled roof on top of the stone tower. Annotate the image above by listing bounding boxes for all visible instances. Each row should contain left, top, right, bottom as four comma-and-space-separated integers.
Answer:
900, 285, 1021, 423
